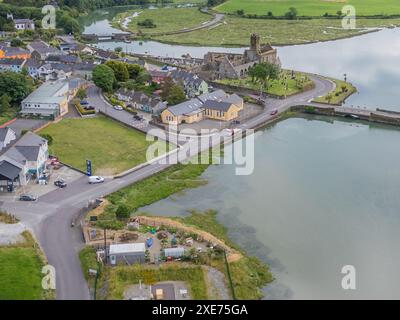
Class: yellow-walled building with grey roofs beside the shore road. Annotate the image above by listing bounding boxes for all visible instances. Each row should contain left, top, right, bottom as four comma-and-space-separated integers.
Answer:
161, 90, 244, 125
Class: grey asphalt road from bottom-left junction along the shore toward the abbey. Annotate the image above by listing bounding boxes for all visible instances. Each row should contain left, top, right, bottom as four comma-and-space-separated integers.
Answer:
0, 76, 334, 300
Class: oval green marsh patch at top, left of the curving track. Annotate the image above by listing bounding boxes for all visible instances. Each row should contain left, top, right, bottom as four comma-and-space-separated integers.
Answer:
112, 8, 212, 34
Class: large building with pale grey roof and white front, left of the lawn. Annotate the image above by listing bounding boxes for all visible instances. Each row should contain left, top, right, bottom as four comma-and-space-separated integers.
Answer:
21, 79, 82, 118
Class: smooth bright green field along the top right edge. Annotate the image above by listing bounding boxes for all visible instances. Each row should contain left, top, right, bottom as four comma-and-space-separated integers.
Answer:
216, 0, 400, 17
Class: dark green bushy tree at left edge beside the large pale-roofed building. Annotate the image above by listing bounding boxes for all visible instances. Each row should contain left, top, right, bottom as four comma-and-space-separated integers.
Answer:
0, 71, 33, 103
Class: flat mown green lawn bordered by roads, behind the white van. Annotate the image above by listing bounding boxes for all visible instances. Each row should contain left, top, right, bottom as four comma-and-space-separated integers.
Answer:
40, 116, 170, 175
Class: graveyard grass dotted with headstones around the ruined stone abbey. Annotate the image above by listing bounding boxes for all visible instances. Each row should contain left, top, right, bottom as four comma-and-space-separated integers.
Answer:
217, 70, 313, 96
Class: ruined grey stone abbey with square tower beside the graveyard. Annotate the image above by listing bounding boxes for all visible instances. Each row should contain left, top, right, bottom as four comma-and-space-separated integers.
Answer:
202, 34, 280, 79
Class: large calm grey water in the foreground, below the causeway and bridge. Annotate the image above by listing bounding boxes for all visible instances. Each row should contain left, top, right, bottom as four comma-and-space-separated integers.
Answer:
143, 118, 400, 299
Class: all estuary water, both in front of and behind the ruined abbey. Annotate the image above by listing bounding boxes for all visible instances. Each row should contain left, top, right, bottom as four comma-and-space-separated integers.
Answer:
80, 10, 400, 299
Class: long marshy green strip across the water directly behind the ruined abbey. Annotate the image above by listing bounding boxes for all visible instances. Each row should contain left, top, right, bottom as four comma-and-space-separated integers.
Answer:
152, 16, 400, 46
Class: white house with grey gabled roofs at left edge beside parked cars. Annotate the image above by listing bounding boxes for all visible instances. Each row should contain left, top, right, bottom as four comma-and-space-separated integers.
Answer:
0, 131, 49, 192
